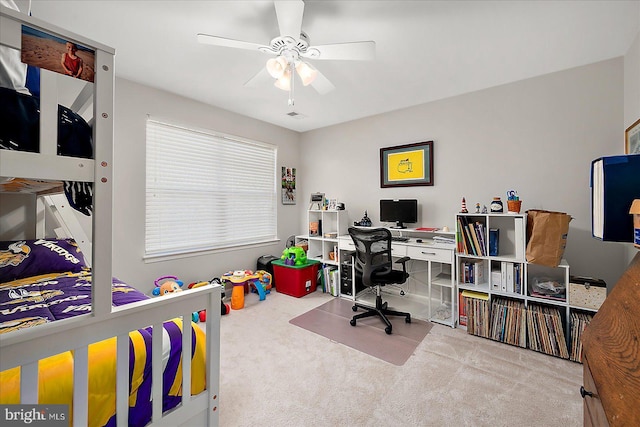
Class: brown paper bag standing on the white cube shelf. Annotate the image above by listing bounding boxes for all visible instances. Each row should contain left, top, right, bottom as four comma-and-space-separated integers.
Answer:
526, 209, 571, 267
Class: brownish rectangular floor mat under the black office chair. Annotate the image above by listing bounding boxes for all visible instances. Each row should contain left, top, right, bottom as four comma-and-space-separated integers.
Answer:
289, 298, 432, 366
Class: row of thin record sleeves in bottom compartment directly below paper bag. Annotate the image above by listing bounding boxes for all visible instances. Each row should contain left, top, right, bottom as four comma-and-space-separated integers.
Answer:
527, 304, 569, 359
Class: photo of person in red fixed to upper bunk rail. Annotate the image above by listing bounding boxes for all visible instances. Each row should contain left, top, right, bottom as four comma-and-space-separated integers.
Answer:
20, 25, 96, 82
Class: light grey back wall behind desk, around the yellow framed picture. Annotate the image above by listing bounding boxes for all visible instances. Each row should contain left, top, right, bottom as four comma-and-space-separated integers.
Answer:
298, 58, 626, 285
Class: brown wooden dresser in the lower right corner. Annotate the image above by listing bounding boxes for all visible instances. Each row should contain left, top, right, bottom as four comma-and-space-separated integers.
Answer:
580, 252, 640, 427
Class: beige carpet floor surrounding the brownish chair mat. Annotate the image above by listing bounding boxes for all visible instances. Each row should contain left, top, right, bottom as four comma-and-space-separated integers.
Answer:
219, 292, 582, 427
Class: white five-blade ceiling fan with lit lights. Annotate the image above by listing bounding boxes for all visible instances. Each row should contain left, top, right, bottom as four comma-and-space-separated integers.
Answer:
198, 0, 376, 106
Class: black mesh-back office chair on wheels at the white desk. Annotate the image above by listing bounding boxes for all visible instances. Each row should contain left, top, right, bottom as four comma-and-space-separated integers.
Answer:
349, 227, 411, 334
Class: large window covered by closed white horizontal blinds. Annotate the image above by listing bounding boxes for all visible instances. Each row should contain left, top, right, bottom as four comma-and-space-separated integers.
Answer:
145, 119, 277, 257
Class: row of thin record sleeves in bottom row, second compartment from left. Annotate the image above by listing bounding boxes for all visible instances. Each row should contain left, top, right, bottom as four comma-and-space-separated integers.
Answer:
491, 298, 527, 348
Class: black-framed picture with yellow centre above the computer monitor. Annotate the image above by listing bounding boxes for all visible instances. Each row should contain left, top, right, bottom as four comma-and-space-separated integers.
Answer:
380, 141, 433, 188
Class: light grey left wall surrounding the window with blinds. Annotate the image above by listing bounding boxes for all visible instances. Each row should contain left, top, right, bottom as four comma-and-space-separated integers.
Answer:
113, 79, 306, 290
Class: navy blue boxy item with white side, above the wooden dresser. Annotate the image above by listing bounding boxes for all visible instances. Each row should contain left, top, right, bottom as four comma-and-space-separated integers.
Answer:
590, 154, 640, 242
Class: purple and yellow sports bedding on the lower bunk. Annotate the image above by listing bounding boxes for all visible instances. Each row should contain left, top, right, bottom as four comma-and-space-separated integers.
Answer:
0, 239, 205, 426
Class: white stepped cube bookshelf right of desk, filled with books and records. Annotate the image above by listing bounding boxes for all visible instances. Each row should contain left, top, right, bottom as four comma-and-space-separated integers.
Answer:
456, 213, 597, 362
